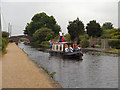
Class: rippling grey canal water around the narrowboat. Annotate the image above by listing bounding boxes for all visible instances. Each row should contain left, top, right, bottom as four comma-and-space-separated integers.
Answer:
18, 44, 118, 88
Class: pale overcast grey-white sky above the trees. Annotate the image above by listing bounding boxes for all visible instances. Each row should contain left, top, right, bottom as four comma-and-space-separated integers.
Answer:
1, 0, 119, 36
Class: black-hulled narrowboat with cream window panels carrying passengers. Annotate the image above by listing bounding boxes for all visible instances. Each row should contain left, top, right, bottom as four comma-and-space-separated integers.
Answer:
49, 42, 83, 59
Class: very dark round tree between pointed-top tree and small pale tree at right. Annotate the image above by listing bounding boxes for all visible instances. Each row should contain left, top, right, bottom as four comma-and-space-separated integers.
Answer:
86, 20, 102, 37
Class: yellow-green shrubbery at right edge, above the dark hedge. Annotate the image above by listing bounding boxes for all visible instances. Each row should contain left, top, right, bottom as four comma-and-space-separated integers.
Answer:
102, 29, 120, 39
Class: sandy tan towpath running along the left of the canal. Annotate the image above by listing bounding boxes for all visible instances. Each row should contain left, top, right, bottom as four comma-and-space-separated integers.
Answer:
2, 43, 61, 88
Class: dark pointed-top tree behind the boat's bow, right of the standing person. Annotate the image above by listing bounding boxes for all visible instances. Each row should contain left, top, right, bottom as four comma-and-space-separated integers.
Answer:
67, 18, 85, 40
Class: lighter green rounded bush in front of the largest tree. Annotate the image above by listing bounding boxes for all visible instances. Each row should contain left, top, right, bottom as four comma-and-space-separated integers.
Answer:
33, 28, 54, 43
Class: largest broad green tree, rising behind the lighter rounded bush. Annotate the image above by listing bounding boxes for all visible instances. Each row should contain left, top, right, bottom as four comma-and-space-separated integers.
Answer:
24, 12, 60, 36
